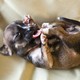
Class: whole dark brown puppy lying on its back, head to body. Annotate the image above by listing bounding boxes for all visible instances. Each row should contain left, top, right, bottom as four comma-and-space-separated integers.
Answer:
2, 16, 80, 69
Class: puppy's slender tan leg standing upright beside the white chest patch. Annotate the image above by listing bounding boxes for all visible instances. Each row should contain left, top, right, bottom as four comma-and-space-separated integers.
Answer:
41, 33, 53, 68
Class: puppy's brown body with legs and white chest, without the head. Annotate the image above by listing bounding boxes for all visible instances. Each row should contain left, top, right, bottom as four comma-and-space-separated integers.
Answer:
27, 18, 80, 69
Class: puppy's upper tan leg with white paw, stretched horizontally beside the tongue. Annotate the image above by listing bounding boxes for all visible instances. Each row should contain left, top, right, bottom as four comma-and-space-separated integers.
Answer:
42, 27, 69, 39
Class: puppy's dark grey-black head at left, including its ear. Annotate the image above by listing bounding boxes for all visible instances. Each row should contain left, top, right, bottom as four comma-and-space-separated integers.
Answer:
0, 16, 39, 56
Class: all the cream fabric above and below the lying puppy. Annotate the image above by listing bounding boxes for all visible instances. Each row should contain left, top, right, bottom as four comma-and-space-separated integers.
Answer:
0, 0, 80, 80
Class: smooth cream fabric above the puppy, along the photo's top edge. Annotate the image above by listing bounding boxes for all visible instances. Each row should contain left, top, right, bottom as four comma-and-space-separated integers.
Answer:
4, 0, 80, 23
